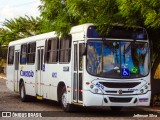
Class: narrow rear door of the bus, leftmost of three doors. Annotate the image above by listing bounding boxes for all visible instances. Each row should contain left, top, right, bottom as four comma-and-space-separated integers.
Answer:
14, 50, 19, 92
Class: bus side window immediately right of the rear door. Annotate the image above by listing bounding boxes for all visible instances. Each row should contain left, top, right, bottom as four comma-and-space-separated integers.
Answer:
20, 44, 27, 64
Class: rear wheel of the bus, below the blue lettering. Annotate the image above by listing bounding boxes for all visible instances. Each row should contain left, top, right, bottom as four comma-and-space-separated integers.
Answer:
20, 82, 27, 102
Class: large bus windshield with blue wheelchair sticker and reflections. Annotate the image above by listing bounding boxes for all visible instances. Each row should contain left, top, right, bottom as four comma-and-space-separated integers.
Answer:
87, 39, 149, 78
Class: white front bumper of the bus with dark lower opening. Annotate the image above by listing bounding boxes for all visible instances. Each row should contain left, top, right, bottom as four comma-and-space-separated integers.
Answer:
83, 91, 151, 106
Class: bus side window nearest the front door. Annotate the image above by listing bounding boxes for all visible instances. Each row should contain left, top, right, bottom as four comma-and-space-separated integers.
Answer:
59, 35, 72, 63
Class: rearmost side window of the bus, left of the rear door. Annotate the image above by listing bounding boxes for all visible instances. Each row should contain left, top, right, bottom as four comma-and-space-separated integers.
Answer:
8, 46, 14, 65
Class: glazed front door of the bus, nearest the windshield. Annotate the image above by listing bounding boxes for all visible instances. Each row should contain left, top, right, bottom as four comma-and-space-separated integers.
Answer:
72, 41, 85, 103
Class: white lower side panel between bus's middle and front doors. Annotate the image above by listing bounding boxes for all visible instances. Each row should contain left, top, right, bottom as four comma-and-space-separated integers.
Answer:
43, 63, 71, 101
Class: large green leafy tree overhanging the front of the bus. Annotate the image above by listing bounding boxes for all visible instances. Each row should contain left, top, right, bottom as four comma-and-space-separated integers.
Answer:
40, 0, 160, 59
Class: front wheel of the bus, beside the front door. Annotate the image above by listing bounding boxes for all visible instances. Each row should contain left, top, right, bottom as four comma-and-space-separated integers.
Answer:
61, 87, 72, 112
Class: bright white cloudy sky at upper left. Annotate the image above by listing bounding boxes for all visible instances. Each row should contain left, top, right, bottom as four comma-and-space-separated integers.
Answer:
0, 0, 41, 26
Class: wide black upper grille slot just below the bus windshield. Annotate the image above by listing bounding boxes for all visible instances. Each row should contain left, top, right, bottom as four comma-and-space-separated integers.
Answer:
99, 82, 140, 88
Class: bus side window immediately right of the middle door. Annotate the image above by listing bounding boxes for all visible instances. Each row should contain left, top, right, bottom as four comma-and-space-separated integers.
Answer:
45, 38, 59, 64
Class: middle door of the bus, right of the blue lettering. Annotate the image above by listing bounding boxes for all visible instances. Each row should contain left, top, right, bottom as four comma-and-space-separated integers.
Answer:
36, 47, 44, 96
